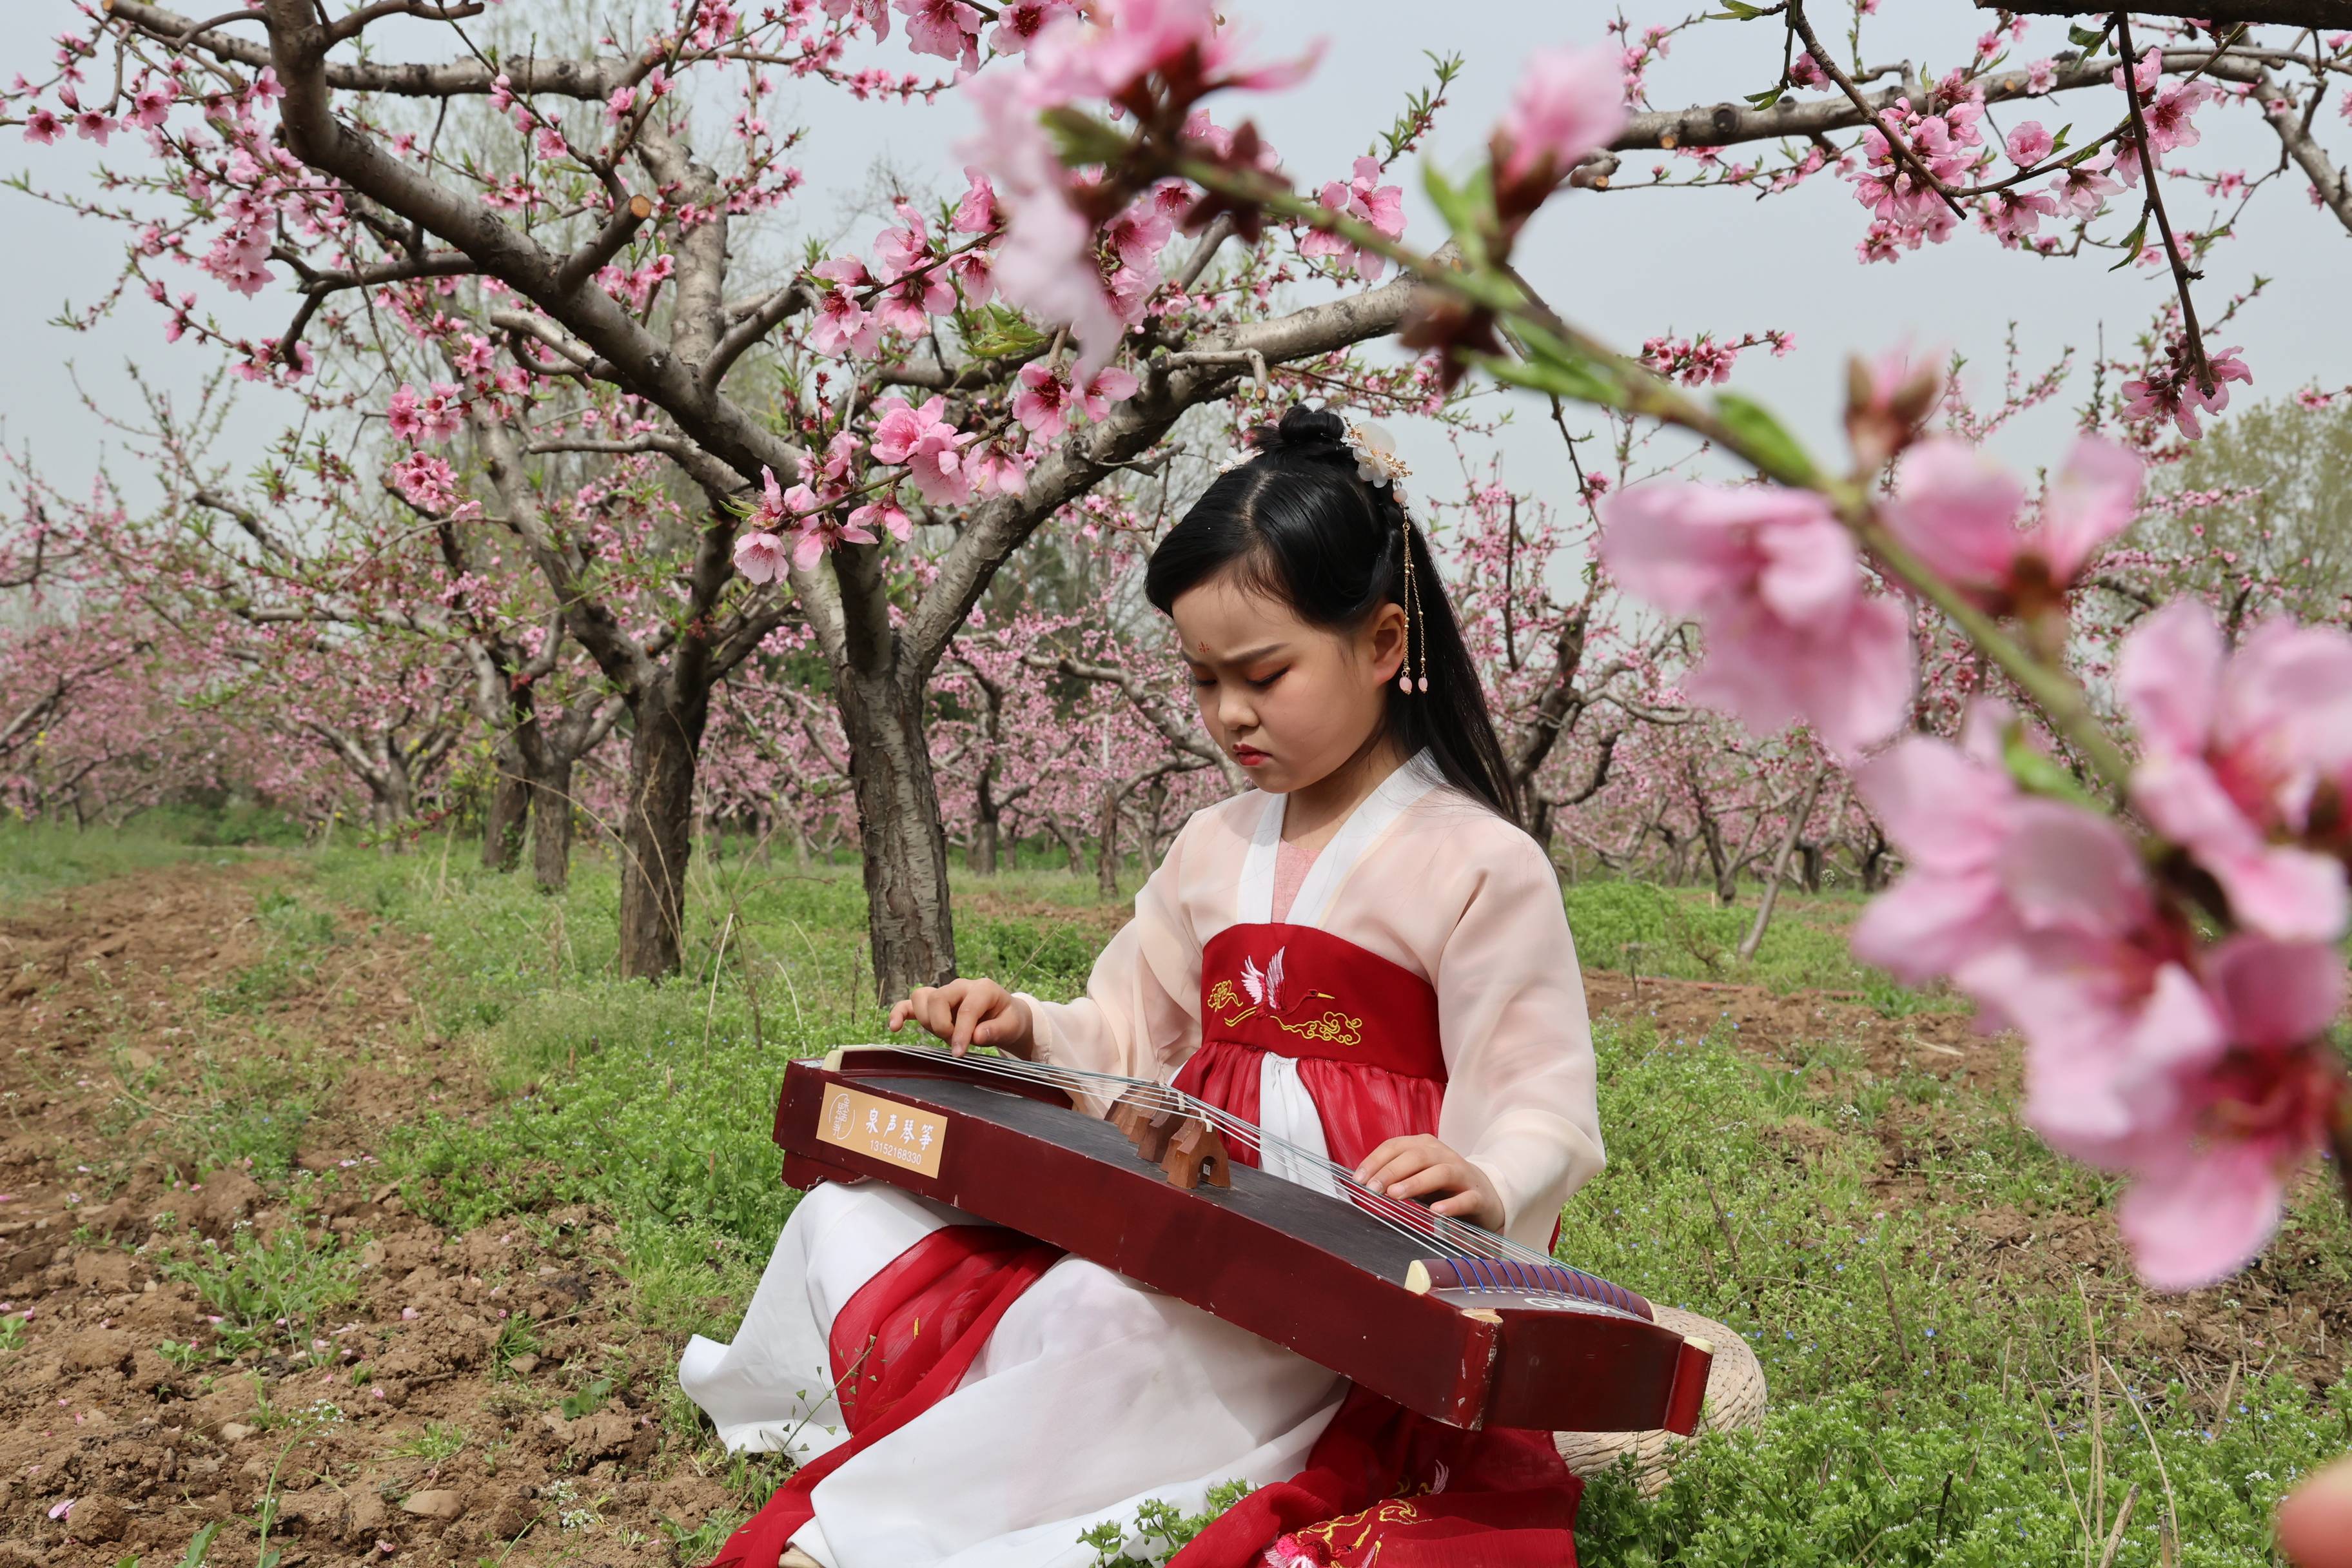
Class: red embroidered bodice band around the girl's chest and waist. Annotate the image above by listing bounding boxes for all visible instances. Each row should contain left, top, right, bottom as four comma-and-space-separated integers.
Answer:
1176, 924, 1447, 1166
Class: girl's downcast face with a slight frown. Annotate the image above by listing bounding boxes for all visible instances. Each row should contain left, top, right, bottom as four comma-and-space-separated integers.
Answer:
1171, 571, 1404, 794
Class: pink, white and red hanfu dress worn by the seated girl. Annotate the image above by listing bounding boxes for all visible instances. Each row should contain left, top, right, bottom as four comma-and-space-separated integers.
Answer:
678, 757, 1602, 1568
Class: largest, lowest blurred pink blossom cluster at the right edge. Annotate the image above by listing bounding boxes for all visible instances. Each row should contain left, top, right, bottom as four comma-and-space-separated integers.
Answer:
1854, 602, 2352, 1288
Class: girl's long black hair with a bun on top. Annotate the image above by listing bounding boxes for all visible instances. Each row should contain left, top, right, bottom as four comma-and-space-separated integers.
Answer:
1143, 404, 1520, 823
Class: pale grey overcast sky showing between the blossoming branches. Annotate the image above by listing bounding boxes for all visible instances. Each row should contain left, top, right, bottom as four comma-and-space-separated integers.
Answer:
0, 0, 2352, 517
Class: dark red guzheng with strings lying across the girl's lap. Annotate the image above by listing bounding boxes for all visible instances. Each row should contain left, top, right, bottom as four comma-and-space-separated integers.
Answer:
776, 1046, 1714, 1434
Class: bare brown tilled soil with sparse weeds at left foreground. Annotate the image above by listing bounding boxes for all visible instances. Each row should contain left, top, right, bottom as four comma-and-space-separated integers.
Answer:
0, 863, 727, 1568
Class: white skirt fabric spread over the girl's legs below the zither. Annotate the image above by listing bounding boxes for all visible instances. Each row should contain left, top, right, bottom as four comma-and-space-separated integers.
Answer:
678, 1182, 1346, 1568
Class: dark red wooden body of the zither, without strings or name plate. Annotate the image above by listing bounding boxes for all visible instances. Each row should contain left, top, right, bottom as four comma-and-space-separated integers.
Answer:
776, 1051, 1710, 1432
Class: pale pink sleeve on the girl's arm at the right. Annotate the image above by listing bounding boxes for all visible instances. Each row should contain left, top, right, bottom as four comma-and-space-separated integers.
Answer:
1435, 821, 1602, 1251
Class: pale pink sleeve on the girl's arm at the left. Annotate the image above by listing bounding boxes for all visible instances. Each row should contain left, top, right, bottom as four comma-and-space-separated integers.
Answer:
1021, 814, 1206, 1081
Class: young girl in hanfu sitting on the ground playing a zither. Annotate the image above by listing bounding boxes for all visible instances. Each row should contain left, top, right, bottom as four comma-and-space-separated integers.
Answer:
678, 409, 1602, 1568
